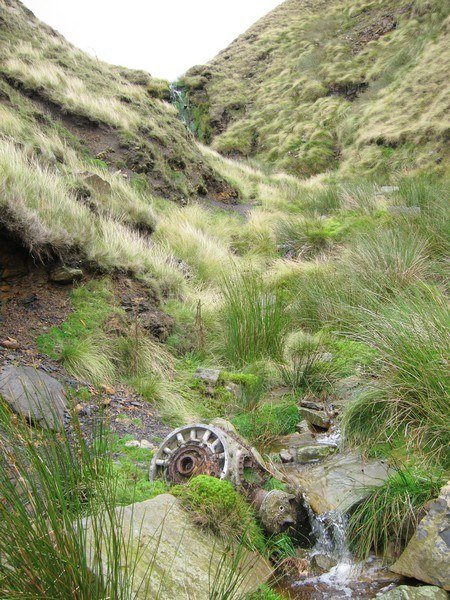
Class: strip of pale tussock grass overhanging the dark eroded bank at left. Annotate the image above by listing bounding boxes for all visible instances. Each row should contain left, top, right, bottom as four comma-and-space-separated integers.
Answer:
0, 140, 183, 291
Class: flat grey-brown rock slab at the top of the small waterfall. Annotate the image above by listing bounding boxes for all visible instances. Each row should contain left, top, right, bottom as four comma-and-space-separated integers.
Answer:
288, 452, 389, 515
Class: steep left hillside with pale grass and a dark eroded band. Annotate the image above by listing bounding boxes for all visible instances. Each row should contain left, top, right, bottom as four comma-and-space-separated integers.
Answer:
0, 0, 235, 282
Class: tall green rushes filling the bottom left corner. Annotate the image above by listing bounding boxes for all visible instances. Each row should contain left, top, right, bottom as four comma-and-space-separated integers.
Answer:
0, 405, 144, 600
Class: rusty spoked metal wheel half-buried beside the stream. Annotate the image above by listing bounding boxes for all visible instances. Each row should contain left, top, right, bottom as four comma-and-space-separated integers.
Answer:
150, 424, 229, 483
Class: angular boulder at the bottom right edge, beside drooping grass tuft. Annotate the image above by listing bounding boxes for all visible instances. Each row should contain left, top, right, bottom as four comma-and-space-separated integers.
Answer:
392, 482, 450, 590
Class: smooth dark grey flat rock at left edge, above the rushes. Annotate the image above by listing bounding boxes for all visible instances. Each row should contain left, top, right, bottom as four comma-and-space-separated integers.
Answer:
0, 365, 68, 429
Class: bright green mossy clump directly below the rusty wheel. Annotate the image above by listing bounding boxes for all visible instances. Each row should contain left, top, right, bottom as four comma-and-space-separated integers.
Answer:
172, 475, 265, 550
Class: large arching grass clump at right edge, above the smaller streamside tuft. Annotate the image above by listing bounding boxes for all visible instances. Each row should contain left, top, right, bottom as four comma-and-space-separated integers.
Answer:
343, 292, 450, 463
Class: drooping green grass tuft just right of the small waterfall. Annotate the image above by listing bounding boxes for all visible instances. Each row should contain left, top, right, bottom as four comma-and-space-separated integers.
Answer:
347, 467, 446, 559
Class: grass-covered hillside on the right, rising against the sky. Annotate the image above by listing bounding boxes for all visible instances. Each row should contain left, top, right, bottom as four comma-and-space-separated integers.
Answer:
181, 0, 450, 177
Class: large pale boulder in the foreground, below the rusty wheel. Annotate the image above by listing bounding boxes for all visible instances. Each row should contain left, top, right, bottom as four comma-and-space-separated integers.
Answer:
84, 494, 272, 600
